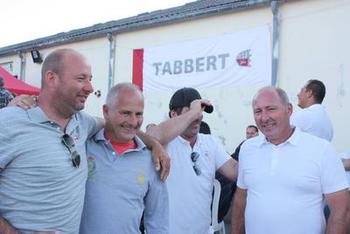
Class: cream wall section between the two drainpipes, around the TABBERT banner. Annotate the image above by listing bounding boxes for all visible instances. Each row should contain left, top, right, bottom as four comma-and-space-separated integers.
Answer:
116, 8, 272, 153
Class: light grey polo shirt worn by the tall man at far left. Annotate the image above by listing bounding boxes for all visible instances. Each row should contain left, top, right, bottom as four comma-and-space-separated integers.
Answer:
0, 107, 98, 233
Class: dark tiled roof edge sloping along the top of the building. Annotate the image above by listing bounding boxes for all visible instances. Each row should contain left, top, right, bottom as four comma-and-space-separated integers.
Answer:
0, 0, 271, 56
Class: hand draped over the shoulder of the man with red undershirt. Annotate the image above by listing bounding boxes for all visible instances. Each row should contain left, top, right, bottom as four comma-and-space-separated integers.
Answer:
152, 142, 170, 181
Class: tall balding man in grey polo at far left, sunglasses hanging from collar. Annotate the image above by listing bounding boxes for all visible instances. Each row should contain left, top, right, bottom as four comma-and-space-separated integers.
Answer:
0, 49, 167, 233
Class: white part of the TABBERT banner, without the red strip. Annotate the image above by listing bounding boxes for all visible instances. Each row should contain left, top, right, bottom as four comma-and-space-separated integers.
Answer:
142, 26, 271, 93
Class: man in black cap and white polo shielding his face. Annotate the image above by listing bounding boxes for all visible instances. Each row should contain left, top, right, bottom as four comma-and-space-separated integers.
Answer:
147, 88, 237, 234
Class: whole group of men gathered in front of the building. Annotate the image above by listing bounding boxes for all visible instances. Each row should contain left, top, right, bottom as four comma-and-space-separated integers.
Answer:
0, 49, 350, 234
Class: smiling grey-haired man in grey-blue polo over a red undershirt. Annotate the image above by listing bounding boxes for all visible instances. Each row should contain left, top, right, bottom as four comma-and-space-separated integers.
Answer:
80, 83, 169, 234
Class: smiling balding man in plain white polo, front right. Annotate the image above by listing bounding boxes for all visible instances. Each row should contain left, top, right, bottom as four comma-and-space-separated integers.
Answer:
232, 87, 350, 234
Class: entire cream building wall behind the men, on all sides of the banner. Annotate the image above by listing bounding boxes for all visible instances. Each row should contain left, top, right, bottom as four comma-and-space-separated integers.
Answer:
0, 0, 350, 153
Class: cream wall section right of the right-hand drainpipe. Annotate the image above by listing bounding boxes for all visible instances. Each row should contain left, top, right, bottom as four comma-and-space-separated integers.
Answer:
278, 0, 350, 151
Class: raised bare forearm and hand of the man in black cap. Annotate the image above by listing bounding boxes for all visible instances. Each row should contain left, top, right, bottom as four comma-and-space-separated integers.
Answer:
147, 99, 210, 145
